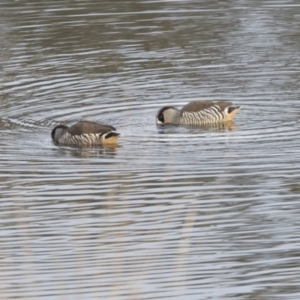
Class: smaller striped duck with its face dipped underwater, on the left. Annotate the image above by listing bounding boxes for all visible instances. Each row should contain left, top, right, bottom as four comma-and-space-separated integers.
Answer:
51, 121, 120, 147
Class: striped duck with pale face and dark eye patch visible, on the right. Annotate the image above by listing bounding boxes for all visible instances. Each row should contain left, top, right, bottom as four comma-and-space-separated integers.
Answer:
156, 100, 241, 125
